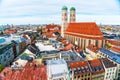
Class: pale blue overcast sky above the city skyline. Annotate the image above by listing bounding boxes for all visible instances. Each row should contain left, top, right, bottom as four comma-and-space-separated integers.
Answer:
0, 0, 120, 25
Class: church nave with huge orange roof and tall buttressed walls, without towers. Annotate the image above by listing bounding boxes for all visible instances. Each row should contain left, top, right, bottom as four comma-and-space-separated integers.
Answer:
65, 22, 105, 49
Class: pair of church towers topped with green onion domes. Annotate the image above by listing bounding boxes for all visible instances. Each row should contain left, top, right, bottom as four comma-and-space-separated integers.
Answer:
61, 6, 76, 37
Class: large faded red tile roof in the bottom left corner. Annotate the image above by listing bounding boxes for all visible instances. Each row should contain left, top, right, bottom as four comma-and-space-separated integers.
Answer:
0, 62, 47, 80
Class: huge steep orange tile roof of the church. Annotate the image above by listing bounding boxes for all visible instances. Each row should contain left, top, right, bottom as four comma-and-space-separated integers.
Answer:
65, 22, 104, 39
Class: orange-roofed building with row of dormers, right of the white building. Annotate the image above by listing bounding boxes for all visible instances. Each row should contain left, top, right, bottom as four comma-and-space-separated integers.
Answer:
68, 61, 92, 80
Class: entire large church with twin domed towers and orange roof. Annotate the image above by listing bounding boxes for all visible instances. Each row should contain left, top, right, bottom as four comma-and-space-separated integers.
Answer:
61, 6, 105, 49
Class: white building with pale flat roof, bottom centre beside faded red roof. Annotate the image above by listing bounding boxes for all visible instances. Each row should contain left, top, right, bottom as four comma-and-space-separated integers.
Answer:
47, 60, 68, 80
